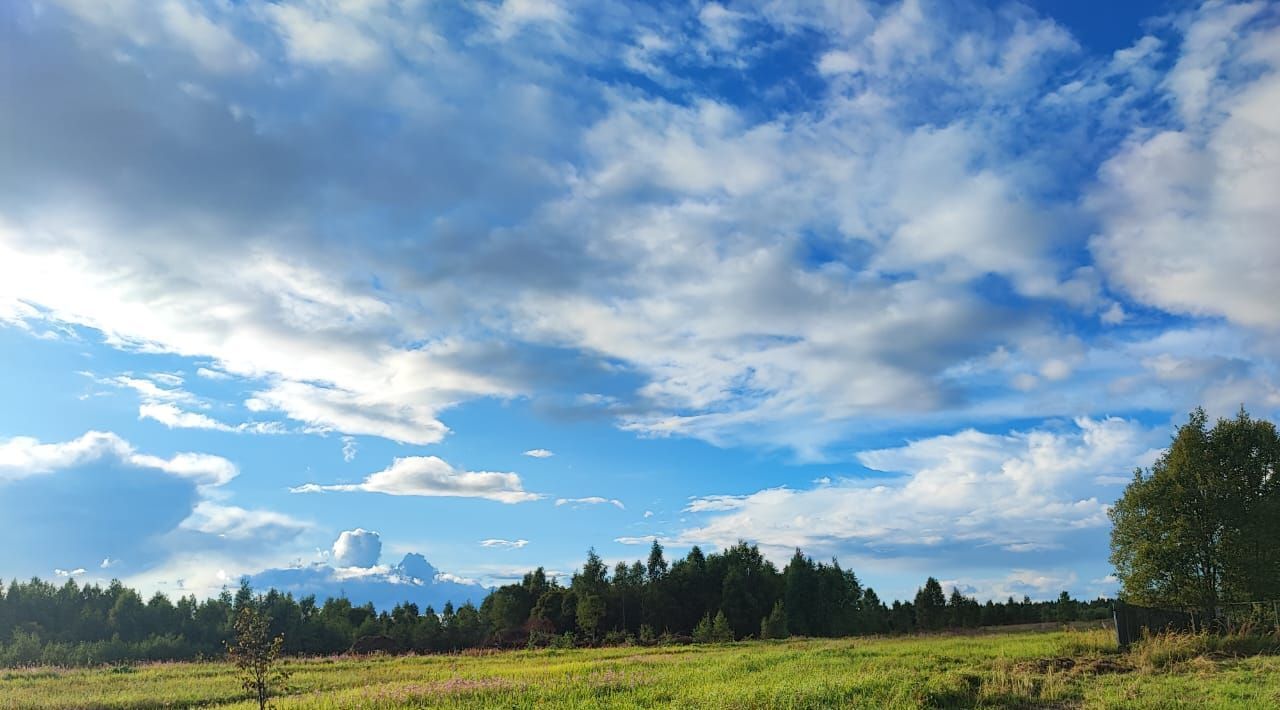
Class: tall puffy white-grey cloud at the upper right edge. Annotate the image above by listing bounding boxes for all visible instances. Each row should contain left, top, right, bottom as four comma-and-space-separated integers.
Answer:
1089, 3, 1280, 329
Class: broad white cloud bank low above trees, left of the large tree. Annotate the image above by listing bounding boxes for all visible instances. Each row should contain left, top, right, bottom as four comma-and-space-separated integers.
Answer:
650, 417, 1161, 560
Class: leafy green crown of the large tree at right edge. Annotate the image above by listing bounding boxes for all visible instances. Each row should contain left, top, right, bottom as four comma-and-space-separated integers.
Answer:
1110, 409, 1280, 610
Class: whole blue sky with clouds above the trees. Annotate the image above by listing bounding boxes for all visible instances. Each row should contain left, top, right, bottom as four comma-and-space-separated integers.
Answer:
0, 0, 1280, 608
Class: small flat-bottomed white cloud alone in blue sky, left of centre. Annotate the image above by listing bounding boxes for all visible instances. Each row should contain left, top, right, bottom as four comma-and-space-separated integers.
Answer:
289, 457, 543, 503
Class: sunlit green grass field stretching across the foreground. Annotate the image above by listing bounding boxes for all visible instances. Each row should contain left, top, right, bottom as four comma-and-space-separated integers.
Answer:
0, 629, 1280, 709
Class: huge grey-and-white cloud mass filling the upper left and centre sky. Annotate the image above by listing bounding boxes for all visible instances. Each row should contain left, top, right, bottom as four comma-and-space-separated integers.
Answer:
0, 0, 1141, 455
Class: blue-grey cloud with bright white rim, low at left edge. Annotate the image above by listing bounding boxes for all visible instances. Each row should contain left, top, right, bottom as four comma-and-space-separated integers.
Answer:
0, 431, 311, 591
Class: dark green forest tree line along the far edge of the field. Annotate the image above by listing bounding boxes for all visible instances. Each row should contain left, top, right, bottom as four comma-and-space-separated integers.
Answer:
0, 541, 1110, 665
